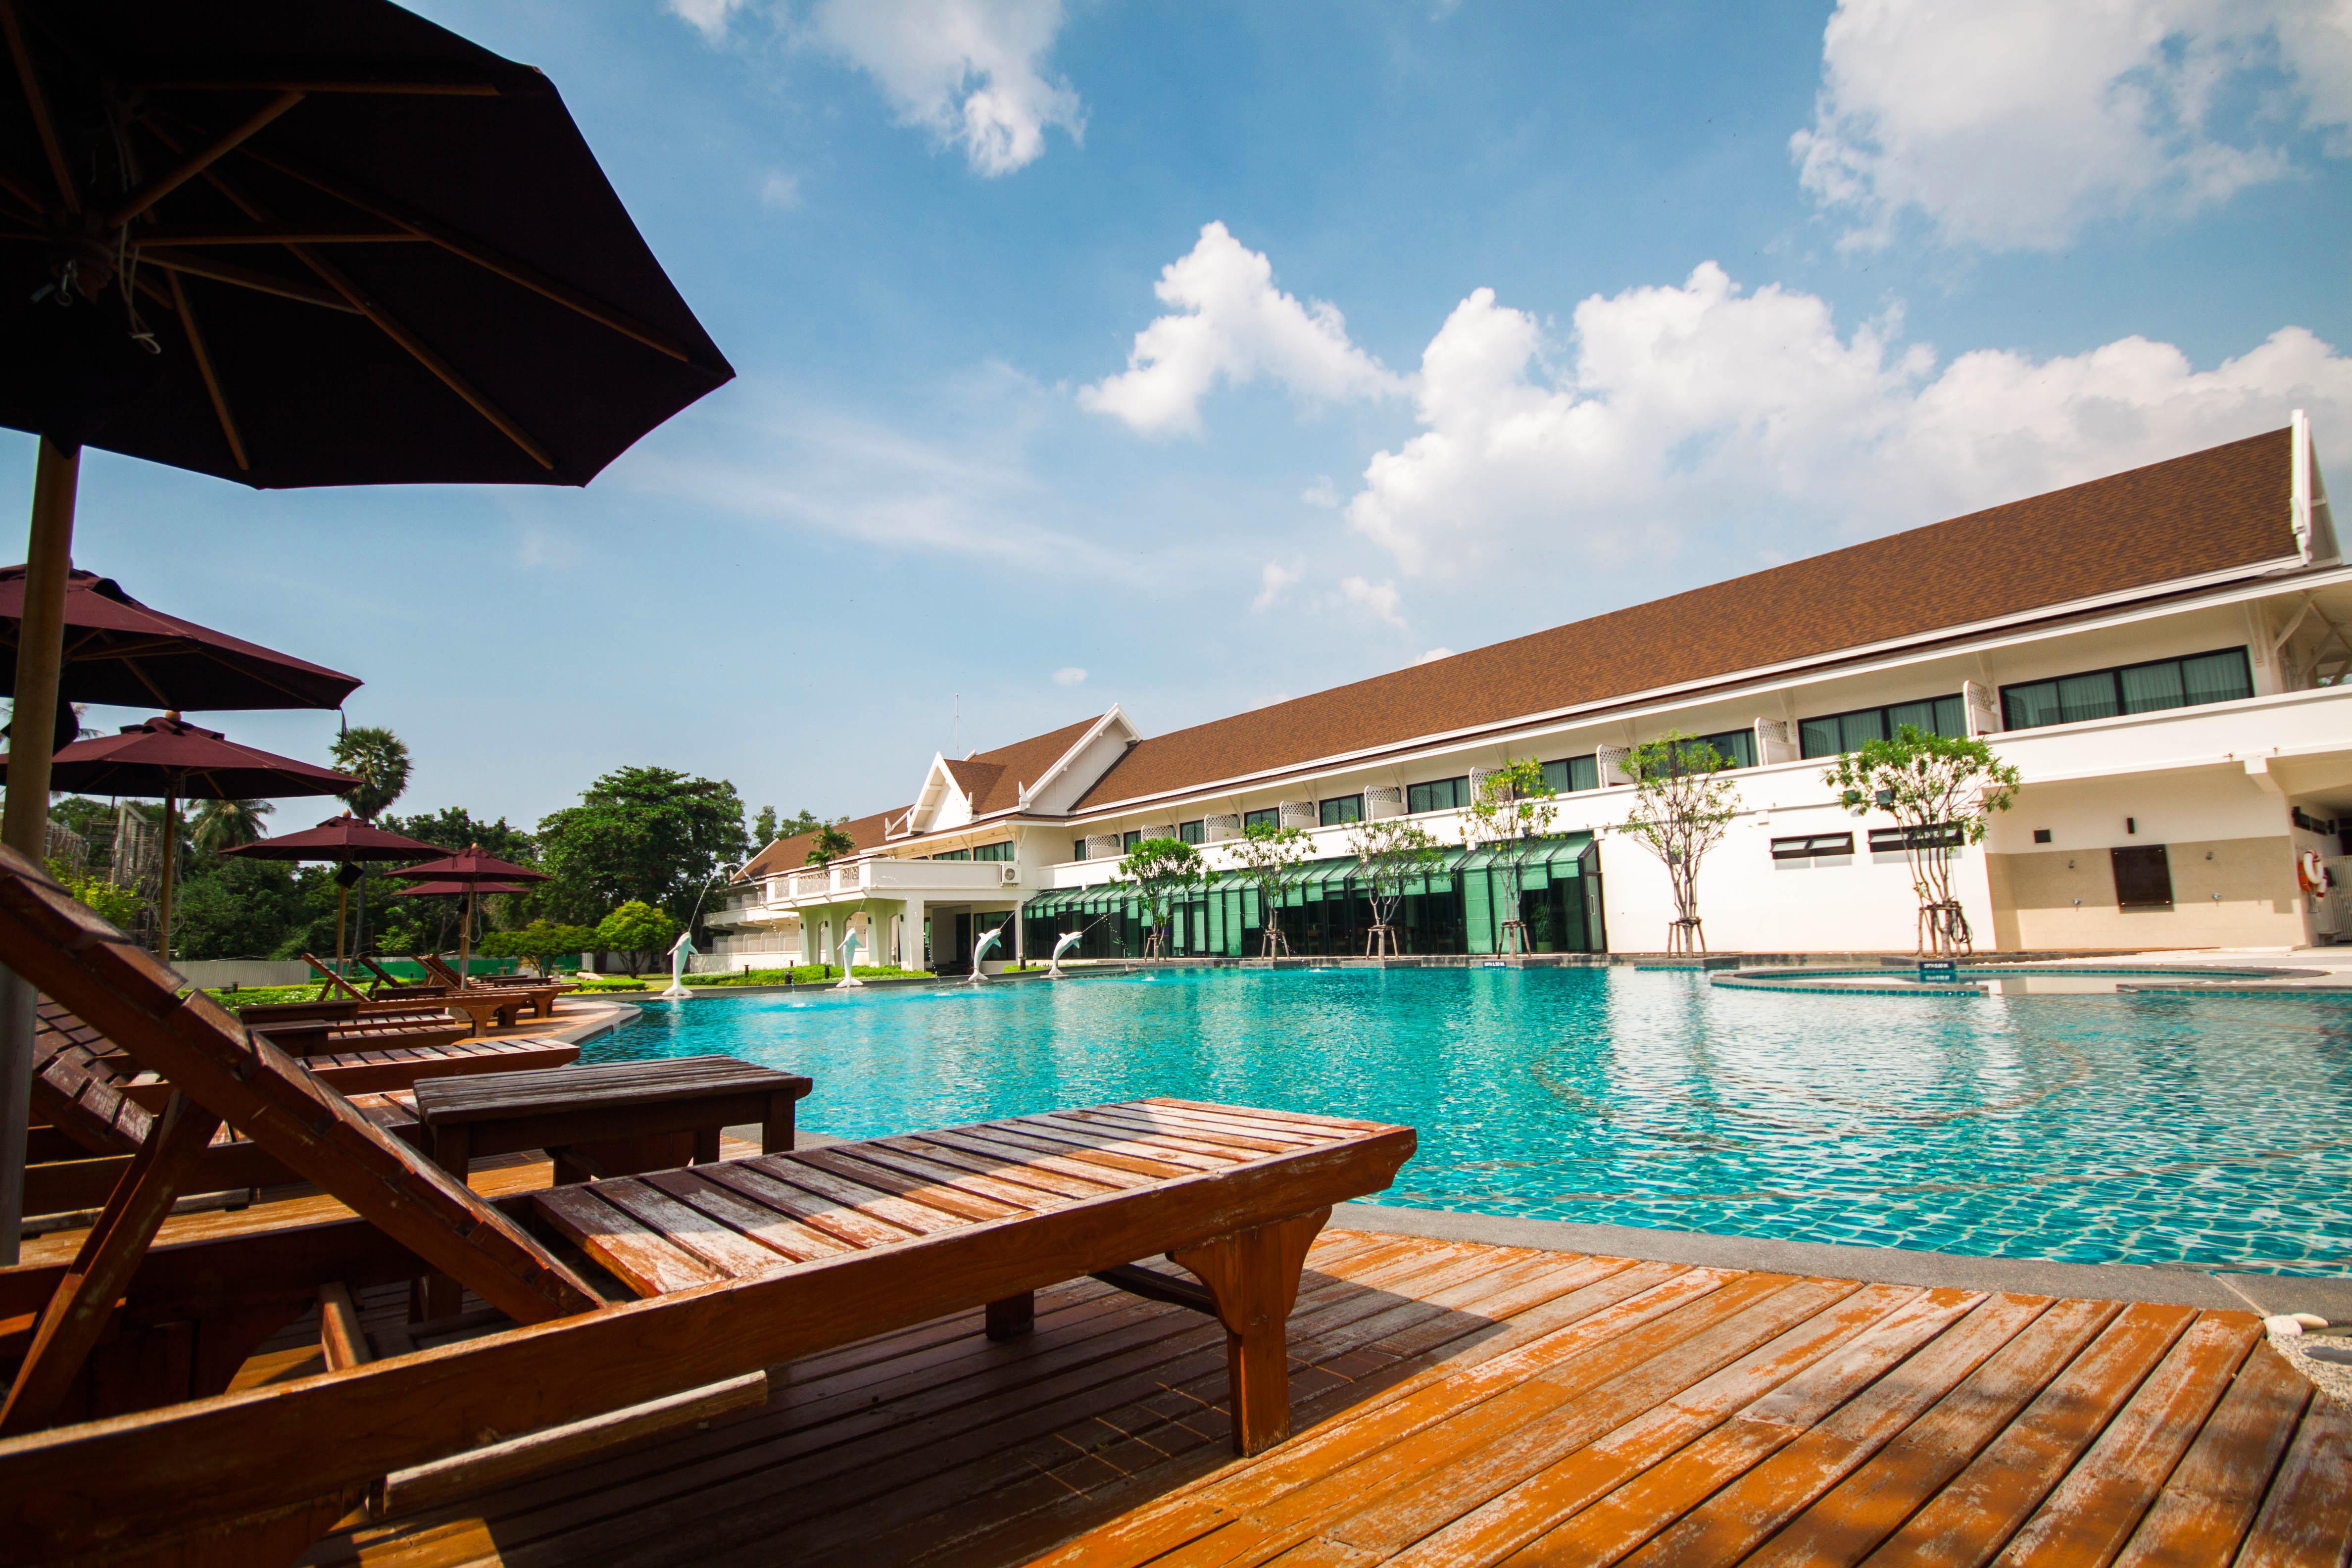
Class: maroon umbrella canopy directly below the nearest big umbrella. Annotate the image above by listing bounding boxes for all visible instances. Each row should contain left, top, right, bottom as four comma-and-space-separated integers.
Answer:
0, 567, 360, 710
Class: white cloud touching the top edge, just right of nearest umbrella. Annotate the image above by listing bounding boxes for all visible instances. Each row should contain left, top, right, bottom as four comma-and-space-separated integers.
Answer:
799, 0, 1086, 174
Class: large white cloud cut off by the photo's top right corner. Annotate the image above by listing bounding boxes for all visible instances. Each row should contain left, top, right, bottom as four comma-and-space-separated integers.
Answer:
1790, 0, 2352, 249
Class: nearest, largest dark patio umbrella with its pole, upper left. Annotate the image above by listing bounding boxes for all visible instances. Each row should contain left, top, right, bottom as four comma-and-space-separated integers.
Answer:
0, 0, 734, 1263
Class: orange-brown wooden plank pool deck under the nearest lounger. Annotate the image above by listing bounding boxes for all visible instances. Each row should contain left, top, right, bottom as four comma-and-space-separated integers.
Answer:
270, 1232, 2352, 1568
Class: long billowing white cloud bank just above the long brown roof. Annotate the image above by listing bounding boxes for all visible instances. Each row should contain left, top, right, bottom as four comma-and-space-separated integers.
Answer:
1345, 261, 2352, 576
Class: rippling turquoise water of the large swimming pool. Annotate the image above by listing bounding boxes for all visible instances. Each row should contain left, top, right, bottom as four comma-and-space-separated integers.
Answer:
586, 969, 2352, 1274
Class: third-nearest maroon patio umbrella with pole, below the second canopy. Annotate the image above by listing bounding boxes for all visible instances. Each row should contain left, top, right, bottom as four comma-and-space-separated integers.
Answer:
0, 712, 360, 964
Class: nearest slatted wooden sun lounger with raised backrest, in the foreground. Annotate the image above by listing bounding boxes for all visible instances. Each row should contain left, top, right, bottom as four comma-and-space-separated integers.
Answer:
0, 849, 1414, 1568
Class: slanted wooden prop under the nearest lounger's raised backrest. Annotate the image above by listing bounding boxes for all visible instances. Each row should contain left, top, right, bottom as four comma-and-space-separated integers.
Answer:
0, 1093, 221, 1436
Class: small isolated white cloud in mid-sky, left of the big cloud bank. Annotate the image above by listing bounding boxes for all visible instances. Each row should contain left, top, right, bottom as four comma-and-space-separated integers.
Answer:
1077, 223, 1404, 435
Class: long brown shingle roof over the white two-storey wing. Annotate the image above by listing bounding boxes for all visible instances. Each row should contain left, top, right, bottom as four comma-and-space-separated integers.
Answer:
1077, 430, 2296, 811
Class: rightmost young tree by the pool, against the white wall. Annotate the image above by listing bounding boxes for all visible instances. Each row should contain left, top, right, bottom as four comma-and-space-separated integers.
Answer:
1823, 724, 2018, 954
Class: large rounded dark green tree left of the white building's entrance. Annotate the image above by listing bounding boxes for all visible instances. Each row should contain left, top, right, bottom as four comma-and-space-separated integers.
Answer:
539, 766, 743, 919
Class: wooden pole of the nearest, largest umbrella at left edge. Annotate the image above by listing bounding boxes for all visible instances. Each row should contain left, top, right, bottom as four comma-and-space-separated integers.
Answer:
0, 435, 82, 1265
